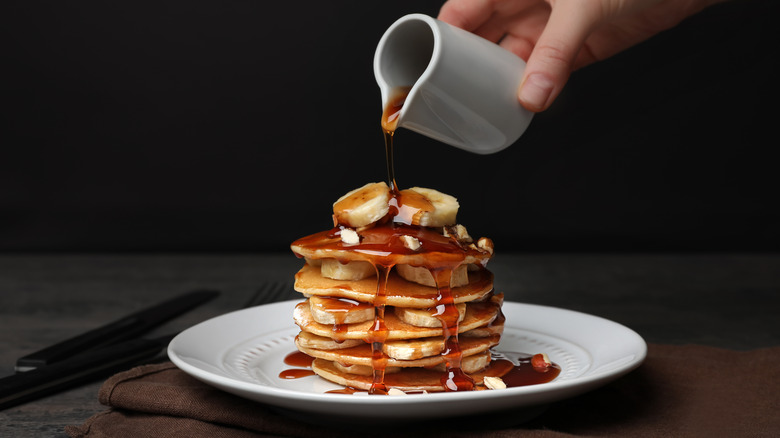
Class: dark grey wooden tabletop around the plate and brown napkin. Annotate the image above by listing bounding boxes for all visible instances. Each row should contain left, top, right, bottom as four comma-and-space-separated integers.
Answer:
0, 253, 780, 437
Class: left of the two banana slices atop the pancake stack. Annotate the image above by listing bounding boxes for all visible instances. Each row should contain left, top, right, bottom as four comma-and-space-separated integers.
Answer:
333, 182, 390, 228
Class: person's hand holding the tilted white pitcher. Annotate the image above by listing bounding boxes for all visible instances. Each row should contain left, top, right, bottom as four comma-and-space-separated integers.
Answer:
438, 0, 725, 112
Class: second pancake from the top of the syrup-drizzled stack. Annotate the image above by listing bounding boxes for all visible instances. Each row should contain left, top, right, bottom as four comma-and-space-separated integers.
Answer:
295, 263, 493, 309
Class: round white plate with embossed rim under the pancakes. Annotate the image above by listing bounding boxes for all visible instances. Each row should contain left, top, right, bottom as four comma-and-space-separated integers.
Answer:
168, 300, 647, 420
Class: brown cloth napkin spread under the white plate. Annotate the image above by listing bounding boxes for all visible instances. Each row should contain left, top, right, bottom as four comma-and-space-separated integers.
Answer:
65, 345, 780, 438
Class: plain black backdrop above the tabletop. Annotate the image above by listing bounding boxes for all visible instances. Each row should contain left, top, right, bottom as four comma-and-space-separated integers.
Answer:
0, 0, 780, 252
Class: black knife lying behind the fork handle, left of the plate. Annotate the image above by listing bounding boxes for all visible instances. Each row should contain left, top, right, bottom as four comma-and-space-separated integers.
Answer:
15, 290, 219, 372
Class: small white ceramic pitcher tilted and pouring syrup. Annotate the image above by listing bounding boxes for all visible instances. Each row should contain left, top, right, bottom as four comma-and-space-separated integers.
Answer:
374, 14, 533, 154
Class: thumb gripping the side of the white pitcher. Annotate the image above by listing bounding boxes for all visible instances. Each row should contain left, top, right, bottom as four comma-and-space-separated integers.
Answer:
518, 0, 599, 112
